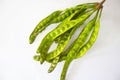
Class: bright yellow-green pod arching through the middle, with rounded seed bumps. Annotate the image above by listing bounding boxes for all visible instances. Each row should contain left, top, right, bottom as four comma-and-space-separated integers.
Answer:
37, 11, 93, 53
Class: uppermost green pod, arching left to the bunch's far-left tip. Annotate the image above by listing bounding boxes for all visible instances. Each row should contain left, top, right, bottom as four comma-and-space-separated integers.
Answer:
29, 4, 94, 44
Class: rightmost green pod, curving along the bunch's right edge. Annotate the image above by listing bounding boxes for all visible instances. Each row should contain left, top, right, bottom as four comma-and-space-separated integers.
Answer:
75, 11, 102, 58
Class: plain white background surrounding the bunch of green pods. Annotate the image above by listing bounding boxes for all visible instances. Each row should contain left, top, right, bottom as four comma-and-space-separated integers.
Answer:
0, 0, 120, 80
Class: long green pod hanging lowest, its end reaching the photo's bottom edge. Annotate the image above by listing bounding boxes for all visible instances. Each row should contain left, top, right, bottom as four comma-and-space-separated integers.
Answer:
60, 10, 97, 80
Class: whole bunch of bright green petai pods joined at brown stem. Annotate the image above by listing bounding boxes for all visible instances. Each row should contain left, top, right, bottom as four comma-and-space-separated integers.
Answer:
29, 0, 105, 80
